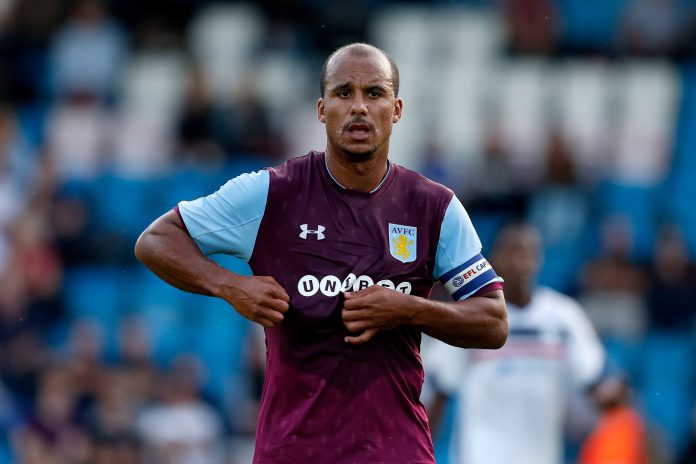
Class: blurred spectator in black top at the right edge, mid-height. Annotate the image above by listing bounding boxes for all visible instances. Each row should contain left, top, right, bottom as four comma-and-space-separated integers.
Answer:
647, 226, 696, 334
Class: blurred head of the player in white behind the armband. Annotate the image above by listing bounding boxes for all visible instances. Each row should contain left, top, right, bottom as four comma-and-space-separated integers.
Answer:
492, 228, 541, 289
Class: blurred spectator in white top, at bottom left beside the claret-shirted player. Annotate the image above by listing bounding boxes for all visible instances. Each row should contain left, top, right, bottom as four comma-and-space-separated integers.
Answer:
137, 357, 223, 464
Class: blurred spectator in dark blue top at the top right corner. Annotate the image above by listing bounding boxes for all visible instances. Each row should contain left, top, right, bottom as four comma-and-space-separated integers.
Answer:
619, 0, 680, 55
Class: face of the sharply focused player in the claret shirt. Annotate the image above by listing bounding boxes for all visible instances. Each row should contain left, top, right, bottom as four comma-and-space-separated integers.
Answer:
317, 53, 403, 161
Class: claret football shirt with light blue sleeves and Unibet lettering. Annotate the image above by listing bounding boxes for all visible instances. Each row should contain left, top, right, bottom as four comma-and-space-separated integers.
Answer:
179, 152, 501, 464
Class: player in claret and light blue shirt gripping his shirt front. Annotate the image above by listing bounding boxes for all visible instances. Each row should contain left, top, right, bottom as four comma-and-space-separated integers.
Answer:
136, 44, 507, 464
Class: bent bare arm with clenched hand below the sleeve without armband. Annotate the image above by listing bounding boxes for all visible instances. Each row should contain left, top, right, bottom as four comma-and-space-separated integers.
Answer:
135, 210, 290, 327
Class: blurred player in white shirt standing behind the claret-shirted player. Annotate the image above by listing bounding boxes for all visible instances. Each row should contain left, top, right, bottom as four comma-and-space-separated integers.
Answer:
424, 224, 605, 464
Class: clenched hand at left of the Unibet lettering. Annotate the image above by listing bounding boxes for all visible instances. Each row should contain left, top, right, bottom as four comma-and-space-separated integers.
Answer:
216, 276, 290, 327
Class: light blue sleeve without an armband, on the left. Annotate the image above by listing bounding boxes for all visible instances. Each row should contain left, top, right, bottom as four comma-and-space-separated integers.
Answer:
179, 170, 270, 261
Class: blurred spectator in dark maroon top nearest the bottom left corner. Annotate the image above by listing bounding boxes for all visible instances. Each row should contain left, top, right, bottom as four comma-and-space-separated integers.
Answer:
15, 365, 90, 464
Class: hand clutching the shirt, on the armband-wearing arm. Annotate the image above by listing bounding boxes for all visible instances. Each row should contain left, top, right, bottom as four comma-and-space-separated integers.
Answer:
341, 285, 411, 345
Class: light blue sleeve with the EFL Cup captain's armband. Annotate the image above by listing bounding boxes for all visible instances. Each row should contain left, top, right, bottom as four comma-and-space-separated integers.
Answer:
433, 196, 502, 301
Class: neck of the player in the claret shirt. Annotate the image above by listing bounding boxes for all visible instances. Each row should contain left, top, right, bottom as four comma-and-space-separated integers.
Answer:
326, 148, 388, 193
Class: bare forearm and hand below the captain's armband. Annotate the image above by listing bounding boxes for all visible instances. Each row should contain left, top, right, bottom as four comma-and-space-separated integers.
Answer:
342, 285, 508, 348
